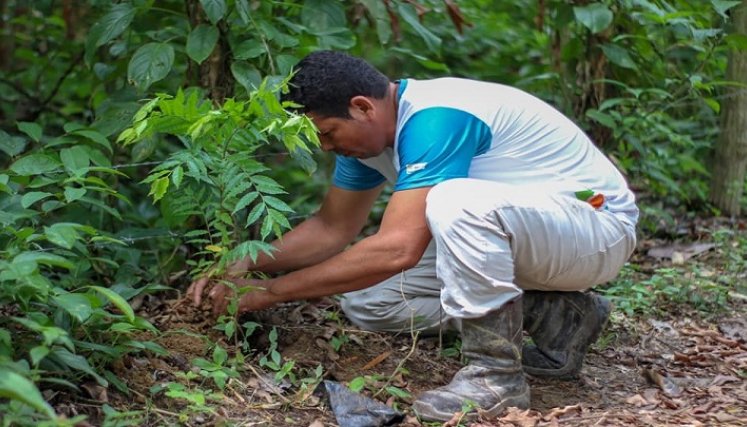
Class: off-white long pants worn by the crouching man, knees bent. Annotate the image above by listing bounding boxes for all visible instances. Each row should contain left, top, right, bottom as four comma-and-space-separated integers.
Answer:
342, 178, 636, 331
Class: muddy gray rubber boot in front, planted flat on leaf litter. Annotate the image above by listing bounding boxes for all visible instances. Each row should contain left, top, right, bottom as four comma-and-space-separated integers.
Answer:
413, 300, 529, 421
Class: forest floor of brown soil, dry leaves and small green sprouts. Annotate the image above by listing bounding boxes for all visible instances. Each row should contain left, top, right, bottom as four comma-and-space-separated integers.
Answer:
53, 219, 747, 427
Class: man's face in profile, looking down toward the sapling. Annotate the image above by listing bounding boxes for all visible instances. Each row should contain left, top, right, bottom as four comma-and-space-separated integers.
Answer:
308, 98, 388, 159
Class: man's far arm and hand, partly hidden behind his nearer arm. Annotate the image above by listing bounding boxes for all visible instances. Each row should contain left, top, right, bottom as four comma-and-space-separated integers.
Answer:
187, 184, 384, 305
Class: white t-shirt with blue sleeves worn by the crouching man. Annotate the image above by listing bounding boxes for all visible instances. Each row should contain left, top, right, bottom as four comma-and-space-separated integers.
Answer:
333, 78, 638, 223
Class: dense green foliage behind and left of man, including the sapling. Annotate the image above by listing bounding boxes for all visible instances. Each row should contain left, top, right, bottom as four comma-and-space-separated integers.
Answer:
0, 0, 747, 424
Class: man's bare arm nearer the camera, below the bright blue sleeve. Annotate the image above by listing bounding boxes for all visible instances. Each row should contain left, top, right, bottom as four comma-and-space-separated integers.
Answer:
241, 187, 431, 310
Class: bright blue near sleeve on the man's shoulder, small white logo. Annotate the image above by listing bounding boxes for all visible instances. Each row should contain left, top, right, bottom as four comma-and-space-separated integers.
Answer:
394, 107, 492, 191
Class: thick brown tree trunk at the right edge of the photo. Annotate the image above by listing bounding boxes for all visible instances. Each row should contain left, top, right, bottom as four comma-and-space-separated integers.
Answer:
710, 0, 747, 216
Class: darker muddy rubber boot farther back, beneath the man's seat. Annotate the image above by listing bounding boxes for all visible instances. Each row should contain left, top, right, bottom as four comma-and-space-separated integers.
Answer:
522, 291, 611, 379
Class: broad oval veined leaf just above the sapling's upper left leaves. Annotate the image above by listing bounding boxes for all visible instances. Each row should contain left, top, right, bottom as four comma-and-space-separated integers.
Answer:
127, 43, 174, 90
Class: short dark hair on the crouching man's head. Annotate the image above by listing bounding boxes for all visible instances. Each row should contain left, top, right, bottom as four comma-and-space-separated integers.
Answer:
283, 50, 389, 119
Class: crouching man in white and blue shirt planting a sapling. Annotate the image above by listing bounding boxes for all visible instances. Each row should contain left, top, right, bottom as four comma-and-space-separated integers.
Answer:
189, 51, 638, 421
